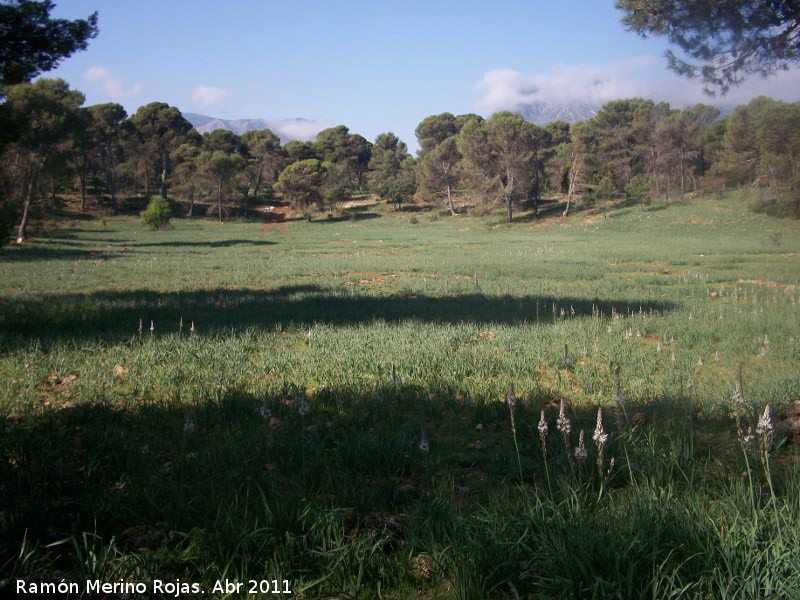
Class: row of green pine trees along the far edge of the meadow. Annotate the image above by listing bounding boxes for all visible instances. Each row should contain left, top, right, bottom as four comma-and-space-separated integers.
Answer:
0, 79, 800, 244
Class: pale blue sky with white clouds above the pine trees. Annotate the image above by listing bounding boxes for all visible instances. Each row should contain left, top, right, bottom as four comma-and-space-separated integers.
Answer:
46, 0, 800, 151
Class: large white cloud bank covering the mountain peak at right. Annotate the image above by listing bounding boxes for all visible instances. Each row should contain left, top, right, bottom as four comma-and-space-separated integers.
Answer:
475, 56, 800, 113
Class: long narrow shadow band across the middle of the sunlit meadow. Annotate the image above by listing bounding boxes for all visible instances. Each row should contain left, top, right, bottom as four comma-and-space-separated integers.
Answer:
0, 285, 675, 341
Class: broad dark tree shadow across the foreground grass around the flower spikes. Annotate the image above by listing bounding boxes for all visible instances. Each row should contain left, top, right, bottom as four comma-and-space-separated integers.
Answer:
0, 382, 793, 597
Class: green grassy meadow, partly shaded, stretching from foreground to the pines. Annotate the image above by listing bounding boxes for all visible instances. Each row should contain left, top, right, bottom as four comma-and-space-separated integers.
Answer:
0, 197, 800, 598
